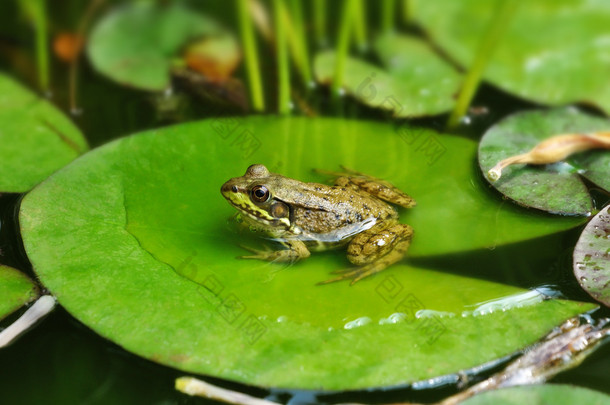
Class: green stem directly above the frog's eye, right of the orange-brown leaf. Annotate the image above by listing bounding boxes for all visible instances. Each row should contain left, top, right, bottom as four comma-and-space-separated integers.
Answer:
237, 0, 265, 111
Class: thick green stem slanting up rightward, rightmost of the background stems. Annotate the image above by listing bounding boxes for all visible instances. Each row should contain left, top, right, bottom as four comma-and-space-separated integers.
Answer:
447, 0, 518, 129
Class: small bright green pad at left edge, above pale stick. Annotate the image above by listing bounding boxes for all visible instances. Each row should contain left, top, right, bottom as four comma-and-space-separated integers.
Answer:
0, 265, 38, 319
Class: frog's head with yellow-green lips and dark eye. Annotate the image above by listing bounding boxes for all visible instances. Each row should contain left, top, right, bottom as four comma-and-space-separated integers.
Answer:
220, 164, 290, 229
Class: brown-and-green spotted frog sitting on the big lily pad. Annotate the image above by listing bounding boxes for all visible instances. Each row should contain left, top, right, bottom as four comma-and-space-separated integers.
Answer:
220, 164, 416, 285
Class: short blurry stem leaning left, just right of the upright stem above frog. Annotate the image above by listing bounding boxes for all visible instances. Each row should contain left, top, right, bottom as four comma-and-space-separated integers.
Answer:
281, 0, 312, 84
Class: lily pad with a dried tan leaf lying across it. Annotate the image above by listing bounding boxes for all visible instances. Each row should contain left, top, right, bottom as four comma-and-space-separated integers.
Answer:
479, 108, 610, 215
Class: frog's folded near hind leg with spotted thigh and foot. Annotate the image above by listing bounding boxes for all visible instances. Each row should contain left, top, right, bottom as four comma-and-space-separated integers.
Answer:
319, 222, 413, 284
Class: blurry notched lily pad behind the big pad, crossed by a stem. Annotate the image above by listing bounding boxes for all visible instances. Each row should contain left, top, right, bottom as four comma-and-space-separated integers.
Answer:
314, 34, 461, 117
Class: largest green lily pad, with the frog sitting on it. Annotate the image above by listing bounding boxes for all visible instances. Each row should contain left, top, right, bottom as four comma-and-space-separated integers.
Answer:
20, 117, 594, 389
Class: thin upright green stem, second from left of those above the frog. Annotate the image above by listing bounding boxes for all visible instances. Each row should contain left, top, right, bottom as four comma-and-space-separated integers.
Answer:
273, 0, 290, 114
